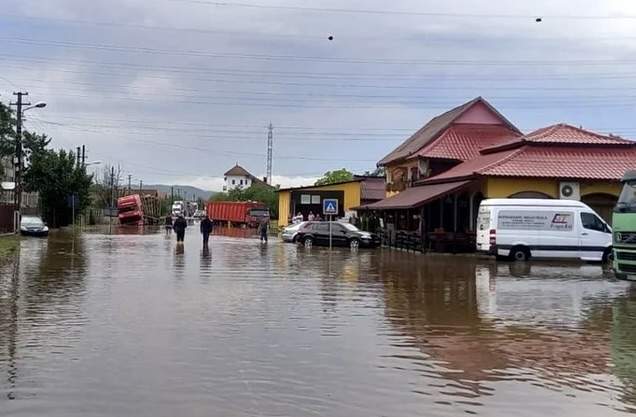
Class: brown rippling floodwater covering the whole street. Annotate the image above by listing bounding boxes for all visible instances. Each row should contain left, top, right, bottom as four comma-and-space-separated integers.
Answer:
0, 230, 636, 417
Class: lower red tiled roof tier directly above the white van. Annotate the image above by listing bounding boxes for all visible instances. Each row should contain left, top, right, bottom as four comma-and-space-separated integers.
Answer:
422, 145, 636, 184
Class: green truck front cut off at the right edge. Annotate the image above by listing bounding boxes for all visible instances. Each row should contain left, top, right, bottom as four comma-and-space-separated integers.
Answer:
612, 171, 636, 281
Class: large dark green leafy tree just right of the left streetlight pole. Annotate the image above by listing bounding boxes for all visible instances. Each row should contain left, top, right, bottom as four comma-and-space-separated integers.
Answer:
24, 148, 93, 227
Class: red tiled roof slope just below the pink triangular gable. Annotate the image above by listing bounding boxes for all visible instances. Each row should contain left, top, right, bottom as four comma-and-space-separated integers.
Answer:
411, 124, 521, 161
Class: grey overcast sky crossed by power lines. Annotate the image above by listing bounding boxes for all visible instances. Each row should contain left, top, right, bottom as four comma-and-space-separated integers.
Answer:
0, 0, 636, 190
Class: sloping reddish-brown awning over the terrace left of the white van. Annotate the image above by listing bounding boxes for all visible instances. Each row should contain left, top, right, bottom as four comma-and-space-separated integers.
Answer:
358, 180, 471, 210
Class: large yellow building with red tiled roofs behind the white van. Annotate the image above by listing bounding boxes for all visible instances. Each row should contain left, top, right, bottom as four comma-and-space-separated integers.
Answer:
361, 97, 636, 250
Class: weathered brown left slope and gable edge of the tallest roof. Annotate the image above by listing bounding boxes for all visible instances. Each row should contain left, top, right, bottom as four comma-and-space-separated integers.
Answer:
378, 97, 516, 165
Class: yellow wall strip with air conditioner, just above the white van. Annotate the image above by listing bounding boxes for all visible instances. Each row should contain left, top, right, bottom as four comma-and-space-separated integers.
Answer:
484, 177, 621, 198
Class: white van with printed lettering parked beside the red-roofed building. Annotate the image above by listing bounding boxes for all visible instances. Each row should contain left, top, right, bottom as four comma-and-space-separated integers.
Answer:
476, 198, 612, 261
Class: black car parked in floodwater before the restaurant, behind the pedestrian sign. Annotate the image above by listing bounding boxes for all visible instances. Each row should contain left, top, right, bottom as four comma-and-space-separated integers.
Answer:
296, 222, 380, 248
